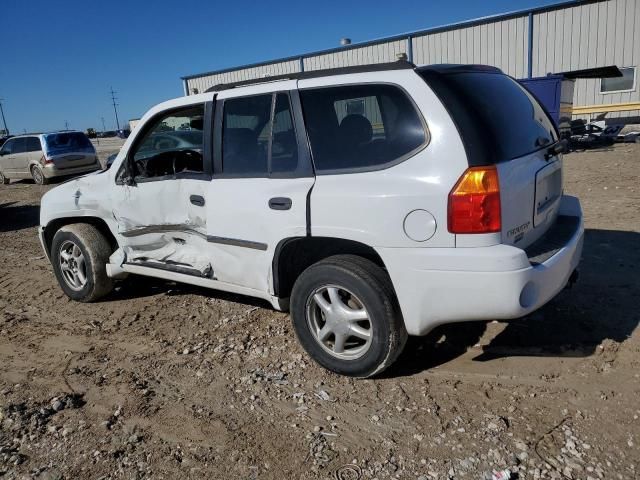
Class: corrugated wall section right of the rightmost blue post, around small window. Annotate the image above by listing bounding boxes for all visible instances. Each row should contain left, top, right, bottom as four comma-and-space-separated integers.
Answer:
532, 0, 640, 118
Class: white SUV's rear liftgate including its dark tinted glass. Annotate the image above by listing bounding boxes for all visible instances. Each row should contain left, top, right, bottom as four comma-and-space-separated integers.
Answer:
418, 65, 562, 248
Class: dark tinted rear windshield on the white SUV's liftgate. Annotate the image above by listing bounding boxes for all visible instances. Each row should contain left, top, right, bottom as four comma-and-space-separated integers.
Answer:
420, 70, 558, 166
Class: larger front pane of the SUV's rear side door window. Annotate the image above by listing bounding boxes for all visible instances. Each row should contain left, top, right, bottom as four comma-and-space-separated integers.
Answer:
222, 94, 273, 175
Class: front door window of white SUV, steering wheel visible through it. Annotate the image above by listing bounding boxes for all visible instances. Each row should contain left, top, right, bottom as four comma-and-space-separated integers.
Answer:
128, 105, 204, 180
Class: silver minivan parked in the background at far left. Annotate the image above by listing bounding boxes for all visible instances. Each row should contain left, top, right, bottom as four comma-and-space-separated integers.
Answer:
0, 131, 100, 185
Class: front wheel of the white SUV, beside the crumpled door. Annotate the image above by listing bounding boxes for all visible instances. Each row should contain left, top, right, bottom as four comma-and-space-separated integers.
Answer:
51, 223, 113, 302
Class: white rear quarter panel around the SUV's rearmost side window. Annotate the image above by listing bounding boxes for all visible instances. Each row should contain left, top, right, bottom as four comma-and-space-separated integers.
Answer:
298, 70, 467, 251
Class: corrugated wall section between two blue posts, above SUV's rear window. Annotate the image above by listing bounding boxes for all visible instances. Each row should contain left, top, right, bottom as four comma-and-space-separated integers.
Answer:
413, 16, 529, 78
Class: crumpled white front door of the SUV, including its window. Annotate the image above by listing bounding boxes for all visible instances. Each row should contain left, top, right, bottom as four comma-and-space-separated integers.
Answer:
112, 103, 215, 279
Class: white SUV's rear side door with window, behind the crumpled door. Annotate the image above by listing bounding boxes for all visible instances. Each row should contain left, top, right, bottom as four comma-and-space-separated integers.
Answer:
207, 81, 315, 294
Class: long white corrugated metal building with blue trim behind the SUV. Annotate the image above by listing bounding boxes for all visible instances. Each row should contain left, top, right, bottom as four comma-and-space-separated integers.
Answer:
182, 0, 640, 120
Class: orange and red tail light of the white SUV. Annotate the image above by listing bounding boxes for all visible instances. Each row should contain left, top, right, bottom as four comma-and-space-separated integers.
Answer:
448, 166, 502, 233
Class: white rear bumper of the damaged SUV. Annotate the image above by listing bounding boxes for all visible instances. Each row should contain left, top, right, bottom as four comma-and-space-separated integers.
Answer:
378, 196, 584, 335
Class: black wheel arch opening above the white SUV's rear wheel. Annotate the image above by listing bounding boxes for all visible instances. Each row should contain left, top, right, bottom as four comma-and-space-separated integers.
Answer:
272, 237, 386, 298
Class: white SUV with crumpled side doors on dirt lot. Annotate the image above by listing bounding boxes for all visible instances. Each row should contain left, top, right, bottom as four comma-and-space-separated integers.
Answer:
40, 62, 583, 377
